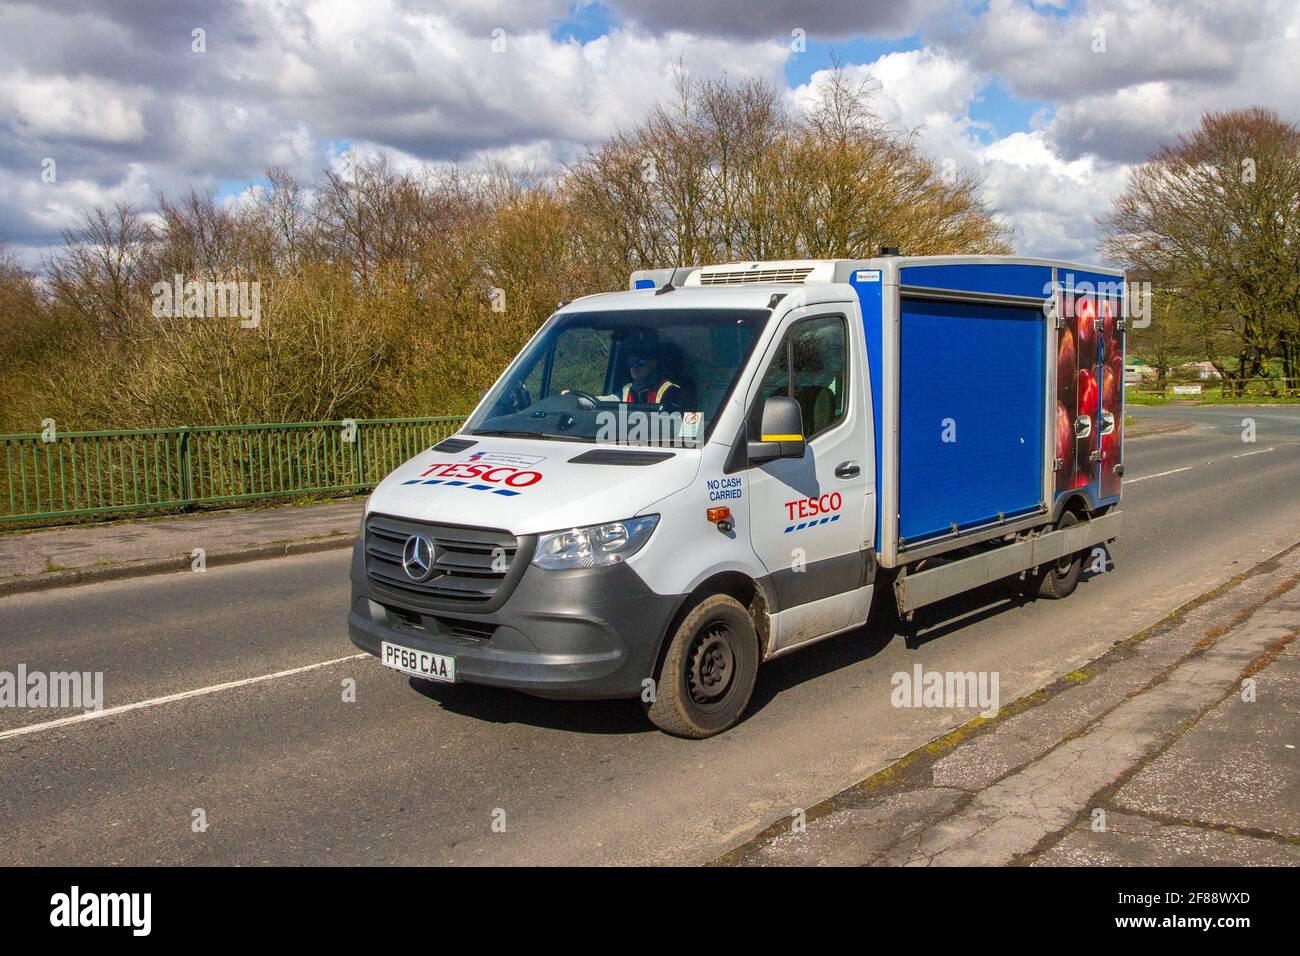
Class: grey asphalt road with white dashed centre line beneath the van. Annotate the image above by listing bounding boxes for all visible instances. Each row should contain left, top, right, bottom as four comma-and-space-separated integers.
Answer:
0, 407, 1300, 865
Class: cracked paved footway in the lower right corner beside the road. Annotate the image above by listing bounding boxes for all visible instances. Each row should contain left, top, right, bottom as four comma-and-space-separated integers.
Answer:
725, 546, 1300, 866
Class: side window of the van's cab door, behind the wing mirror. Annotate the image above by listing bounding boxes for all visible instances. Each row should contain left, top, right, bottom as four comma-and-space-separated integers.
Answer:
749, 316, 849, 441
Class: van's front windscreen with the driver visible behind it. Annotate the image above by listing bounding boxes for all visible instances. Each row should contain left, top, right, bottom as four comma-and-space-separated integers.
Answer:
465, 308, 771, 446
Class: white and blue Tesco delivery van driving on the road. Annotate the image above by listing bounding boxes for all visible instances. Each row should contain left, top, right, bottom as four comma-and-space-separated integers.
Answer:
348, 255, 1125, 737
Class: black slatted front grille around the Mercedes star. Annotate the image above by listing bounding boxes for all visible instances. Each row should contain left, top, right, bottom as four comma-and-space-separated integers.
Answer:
365, 515, 532, 610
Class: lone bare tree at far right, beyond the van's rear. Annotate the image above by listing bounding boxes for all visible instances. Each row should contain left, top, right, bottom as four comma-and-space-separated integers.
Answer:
1100, 108, 1300, 394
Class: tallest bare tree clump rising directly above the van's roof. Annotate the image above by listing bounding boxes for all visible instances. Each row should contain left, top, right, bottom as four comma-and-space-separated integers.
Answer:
564, 69, 1009, 274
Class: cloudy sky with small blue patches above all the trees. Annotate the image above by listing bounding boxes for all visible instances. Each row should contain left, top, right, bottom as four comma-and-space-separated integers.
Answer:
0, 0, 1300, 263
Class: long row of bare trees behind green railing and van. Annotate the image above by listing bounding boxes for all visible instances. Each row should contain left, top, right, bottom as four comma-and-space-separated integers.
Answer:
0, 70, 1024, 427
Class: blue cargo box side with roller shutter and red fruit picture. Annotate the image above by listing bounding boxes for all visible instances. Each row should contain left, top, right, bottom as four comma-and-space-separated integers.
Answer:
833, 256, 1126, 567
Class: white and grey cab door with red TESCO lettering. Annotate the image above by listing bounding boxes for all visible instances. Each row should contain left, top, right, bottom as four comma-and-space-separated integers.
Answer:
746, 307, 875, 653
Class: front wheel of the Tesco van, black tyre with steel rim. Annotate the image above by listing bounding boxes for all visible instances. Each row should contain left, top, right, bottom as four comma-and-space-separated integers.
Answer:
646, 594, 758, 740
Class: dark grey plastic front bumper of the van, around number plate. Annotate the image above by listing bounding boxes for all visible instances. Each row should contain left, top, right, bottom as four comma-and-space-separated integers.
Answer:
347, 538, 683, 698
